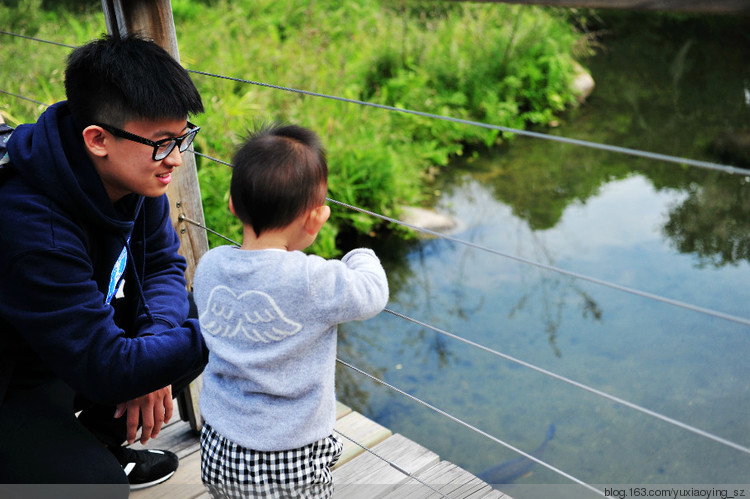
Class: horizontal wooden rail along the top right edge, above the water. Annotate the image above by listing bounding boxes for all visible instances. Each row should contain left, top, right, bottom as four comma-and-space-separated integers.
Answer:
444, 0, 750, 15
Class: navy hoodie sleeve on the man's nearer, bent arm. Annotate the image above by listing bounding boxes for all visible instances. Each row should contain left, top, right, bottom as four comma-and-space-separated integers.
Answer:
0, 192, 207, 403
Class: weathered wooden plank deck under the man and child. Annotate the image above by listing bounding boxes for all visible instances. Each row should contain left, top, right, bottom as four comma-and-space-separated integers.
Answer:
130, 403, 511, 499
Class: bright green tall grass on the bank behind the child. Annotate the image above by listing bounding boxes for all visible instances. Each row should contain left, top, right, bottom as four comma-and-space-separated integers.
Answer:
0, 0, 586, 255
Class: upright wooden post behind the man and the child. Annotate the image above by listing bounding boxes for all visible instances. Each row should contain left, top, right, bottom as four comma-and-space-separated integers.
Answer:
102, 0, 208, 430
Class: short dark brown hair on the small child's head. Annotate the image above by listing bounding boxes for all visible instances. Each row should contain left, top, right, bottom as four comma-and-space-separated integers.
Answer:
230, 123, 328, 236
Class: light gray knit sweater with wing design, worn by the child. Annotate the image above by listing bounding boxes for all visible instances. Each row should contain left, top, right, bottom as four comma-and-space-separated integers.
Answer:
194, 246, 388, 451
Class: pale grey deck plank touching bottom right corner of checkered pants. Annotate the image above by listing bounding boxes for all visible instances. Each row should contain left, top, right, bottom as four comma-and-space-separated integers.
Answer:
333, 434, 440, 499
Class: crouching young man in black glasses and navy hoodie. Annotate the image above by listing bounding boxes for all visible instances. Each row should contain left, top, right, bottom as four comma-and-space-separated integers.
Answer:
0, 37, 208, 496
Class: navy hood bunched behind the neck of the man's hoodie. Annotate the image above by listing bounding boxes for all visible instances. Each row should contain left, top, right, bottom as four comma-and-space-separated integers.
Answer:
8, 101, 143, 234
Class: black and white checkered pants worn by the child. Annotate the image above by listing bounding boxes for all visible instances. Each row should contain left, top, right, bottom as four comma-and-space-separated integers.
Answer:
201, 423, 343, 499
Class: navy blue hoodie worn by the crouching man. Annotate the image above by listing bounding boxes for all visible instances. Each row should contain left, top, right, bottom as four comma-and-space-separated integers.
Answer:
0, 102, 208, 404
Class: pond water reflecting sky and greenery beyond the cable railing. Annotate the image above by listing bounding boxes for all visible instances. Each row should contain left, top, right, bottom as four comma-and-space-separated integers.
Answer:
337, 10, 750, 499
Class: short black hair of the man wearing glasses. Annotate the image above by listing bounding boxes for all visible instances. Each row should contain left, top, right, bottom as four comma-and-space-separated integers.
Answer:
65, 34, 203, 129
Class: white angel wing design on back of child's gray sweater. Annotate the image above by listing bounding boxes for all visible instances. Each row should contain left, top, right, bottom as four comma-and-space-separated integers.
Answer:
200, 286, 302, 343
